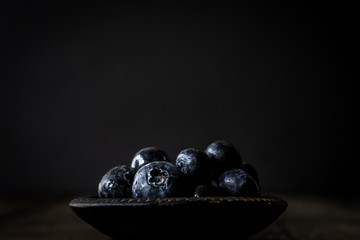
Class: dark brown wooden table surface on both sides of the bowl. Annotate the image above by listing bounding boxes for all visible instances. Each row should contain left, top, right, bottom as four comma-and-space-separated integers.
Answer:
0, 195, 360, 240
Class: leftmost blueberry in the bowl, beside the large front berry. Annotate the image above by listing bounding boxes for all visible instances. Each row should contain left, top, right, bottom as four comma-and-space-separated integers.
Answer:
98, 165, 135, 198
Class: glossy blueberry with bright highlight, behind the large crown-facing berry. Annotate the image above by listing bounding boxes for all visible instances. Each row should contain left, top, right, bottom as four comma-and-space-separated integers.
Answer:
131, 147, 170, 171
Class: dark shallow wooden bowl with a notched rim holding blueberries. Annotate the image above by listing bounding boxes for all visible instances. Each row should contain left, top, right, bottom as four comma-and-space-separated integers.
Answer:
69, 196, 287, 239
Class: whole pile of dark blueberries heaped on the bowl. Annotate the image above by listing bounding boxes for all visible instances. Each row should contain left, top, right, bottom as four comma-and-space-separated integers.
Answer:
98, 141, 261, 198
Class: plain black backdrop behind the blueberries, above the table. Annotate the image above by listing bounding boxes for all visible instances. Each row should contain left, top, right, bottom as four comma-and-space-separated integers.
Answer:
0, 1, 350, 195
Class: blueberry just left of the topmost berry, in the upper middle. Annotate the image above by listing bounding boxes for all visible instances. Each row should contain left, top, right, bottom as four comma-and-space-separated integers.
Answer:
175, 148, 212, 182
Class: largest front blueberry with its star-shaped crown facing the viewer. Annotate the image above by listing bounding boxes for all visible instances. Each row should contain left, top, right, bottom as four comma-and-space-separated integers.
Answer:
132, 161, 182, 198
